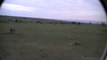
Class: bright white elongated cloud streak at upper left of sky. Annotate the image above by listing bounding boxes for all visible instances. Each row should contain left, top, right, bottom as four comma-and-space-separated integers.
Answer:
2, 3, 36, 12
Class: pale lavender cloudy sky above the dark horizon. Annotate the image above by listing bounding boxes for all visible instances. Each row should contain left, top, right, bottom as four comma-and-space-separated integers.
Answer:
0, 0, 107, 22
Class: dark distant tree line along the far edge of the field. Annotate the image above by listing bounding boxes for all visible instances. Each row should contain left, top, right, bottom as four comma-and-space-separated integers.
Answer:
0, 19, 107, 26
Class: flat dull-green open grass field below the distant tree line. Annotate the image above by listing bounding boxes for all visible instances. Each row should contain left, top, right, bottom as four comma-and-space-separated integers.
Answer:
0, 23, 107, 60
